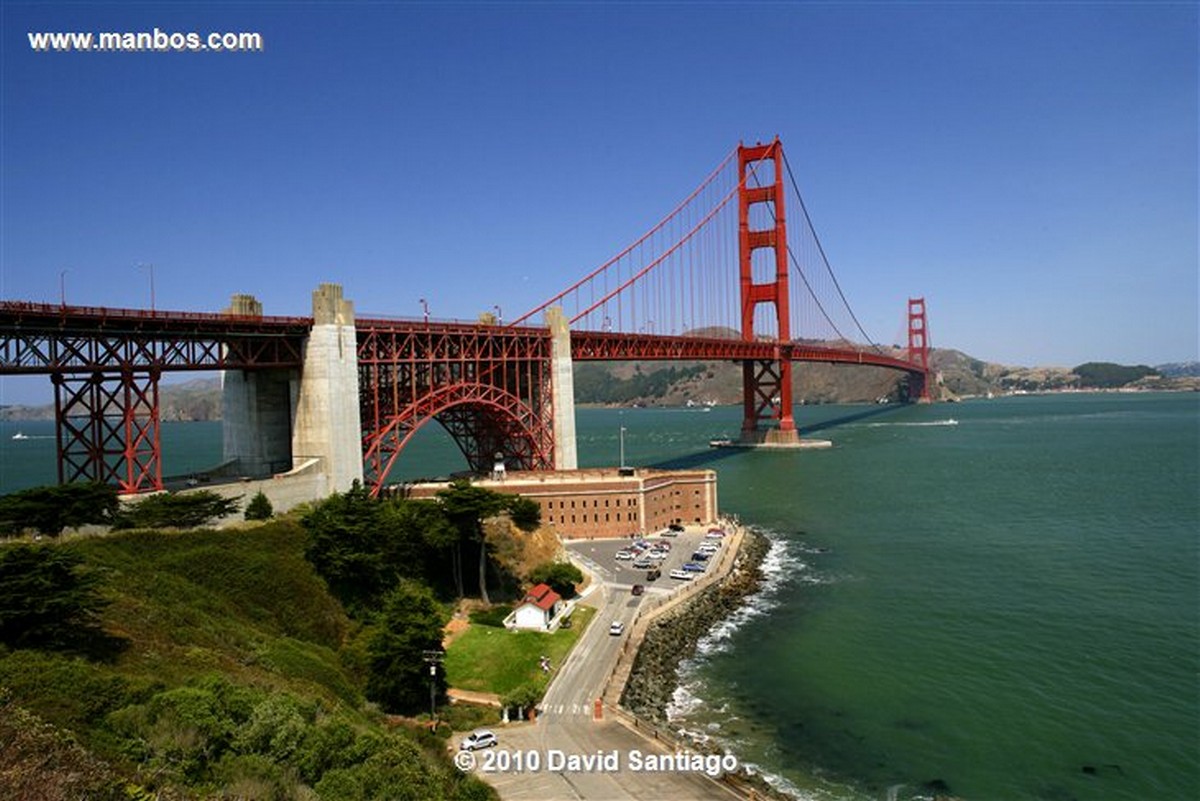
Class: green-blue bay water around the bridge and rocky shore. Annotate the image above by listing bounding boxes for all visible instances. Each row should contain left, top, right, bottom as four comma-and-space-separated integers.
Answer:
0, 395, 1200, 801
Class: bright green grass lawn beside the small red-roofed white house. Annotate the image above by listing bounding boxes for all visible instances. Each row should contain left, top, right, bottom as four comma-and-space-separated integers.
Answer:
445, 604, 595, 697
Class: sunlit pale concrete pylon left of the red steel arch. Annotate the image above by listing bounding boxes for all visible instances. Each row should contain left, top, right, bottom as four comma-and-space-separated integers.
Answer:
292, 284, 362, 494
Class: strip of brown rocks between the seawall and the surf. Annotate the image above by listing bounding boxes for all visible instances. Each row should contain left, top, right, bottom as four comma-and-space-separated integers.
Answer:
620, 529, 770, 723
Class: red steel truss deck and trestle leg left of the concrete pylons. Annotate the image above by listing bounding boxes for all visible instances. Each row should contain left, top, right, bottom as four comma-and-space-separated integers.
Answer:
0, 302, 312, 493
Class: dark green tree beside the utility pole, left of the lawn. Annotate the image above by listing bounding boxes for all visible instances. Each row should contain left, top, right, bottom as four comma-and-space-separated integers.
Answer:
366, 580, 449, 713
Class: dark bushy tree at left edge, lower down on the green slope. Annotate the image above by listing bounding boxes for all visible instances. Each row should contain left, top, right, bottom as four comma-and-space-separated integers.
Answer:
0, 546, 110, 651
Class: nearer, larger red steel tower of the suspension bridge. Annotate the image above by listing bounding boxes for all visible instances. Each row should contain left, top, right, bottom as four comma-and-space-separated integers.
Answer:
738, 137, 799, 445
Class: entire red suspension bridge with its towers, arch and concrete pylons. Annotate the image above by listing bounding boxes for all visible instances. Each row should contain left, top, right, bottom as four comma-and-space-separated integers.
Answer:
0, 139, 931, 493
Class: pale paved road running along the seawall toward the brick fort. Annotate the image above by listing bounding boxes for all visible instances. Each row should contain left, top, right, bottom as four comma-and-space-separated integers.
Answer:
460, 532, 742, 801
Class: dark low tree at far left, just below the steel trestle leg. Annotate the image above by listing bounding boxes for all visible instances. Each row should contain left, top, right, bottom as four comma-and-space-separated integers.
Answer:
0, 482, 120, 536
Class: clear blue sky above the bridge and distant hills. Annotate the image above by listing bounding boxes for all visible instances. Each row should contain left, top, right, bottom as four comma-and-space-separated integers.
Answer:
0, 2, 1200, 402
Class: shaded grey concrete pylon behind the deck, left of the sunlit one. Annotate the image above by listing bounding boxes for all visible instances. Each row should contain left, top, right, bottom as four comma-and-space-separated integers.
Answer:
221, 295, 299, 477
